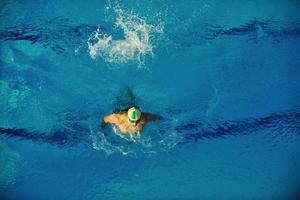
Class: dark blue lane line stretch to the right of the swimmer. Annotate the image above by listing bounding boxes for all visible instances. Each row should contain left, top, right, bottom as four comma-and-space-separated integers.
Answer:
175, 108, 300, 143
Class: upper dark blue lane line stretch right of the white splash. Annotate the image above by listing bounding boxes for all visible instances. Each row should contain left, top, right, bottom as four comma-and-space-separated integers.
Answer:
169, 20, 300, 46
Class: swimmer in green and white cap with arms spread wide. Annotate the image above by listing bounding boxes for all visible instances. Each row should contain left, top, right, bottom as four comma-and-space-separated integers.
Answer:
102, 106, 162, 135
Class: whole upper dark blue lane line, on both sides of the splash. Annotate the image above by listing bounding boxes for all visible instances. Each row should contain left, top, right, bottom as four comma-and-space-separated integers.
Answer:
0, 18, 300, 54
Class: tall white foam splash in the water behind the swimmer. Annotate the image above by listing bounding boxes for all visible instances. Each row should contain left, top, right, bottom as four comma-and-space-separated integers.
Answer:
88, 2, 164, 66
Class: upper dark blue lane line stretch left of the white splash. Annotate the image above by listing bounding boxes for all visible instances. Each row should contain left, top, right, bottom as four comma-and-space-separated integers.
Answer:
0, 18, 102, 54
